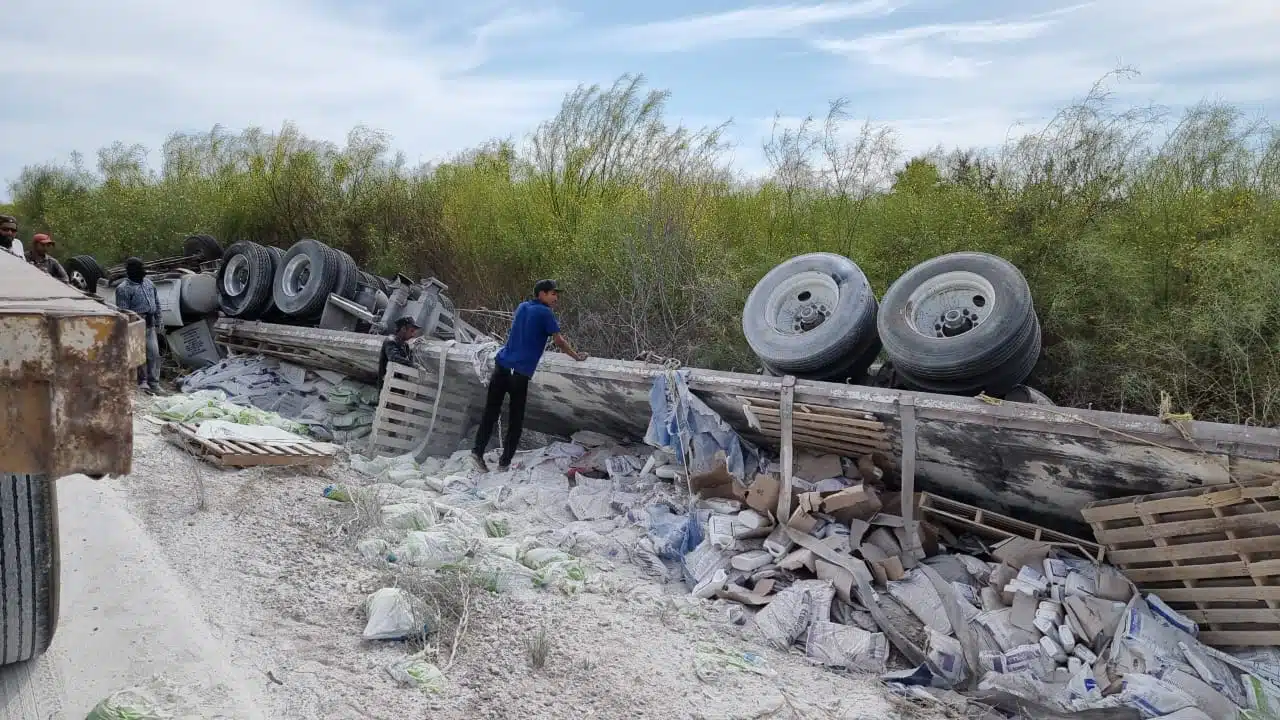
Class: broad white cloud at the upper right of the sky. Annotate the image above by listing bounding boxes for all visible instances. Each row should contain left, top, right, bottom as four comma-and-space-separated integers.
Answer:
788, 0, 1280, 162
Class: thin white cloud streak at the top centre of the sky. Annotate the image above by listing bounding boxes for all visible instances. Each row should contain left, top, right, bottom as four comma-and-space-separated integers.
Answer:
602, 0, 904, 53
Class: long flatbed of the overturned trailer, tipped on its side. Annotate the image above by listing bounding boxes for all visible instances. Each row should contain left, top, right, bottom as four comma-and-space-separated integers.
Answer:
216, 319, 1280, 528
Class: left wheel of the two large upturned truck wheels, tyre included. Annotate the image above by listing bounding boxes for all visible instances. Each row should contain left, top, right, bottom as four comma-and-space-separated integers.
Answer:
742, 252, 879, 380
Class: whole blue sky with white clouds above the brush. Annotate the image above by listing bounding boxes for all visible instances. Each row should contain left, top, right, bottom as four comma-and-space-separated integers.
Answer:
0, 0, 1280, 190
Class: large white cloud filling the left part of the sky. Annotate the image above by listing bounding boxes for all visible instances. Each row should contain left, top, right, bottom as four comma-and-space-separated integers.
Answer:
0, 0, 576, 188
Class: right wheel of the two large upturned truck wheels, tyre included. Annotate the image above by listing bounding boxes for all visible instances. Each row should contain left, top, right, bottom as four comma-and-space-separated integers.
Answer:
878, 252, 1041, 397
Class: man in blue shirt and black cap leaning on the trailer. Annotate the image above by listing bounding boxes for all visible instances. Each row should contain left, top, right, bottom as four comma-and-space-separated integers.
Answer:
471, 281, 586, 473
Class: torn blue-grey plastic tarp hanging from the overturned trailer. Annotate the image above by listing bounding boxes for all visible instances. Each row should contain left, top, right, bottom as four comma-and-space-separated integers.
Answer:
644, 370, 760, 483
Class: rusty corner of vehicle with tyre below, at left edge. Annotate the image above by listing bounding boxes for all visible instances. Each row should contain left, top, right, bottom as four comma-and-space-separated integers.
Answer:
0, 252, 146, 665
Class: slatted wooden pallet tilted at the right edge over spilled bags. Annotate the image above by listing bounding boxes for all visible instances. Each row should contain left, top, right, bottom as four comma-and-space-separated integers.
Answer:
1082, 480, 1280, 646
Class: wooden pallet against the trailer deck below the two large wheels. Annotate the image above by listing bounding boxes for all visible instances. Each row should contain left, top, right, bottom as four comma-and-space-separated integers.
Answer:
742, 397, 893, 456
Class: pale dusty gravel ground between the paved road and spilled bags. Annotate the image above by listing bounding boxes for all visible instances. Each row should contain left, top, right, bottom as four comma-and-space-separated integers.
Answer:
106, 402, 941, 720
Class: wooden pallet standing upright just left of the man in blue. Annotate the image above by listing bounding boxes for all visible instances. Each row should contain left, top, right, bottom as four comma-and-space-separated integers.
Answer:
369, 361, 476, 457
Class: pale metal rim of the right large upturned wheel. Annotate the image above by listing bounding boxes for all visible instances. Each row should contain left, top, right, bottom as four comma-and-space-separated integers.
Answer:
906, 270, 996, 338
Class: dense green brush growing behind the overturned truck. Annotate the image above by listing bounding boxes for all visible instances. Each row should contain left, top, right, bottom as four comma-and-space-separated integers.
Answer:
12, 73, 1280, 425
